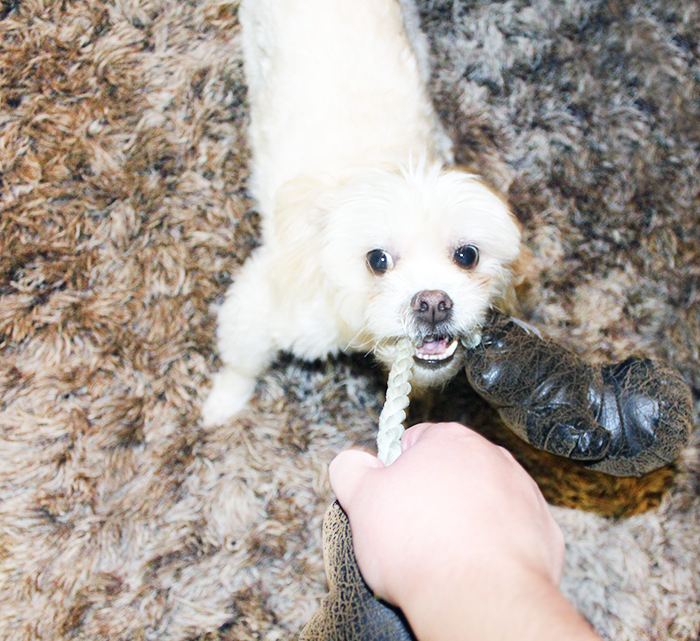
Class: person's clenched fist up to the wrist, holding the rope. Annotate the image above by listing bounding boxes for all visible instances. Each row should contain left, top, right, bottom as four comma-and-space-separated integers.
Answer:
330, 423, 564, 604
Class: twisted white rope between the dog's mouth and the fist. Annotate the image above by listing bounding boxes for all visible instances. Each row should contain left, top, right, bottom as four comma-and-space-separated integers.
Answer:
377, 337, 415, 465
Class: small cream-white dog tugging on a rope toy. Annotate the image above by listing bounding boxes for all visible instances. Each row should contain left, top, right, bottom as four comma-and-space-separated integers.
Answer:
204, 0, 520, 424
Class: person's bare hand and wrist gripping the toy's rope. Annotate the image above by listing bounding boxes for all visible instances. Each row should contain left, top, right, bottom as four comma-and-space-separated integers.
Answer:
330, 423, 596, 639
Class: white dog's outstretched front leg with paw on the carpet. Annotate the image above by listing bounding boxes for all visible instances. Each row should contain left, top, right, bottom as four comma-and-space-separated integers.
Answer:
202, 248, 277, 426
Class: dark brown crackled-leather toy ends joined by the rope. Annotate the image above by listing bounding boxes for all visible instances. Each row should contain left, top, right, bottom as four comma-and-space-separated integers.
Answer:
300, 314, 693, 641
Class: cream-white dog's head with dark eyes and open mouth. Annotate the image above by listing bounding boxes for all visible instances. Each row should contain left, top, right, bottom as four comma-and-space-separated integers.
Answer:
321, 162, 520, 386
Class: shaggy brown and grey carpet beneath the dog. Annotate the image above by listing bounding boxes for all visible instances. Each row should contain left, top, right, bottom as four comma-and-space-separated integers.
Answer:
0, 0, 700, 641
